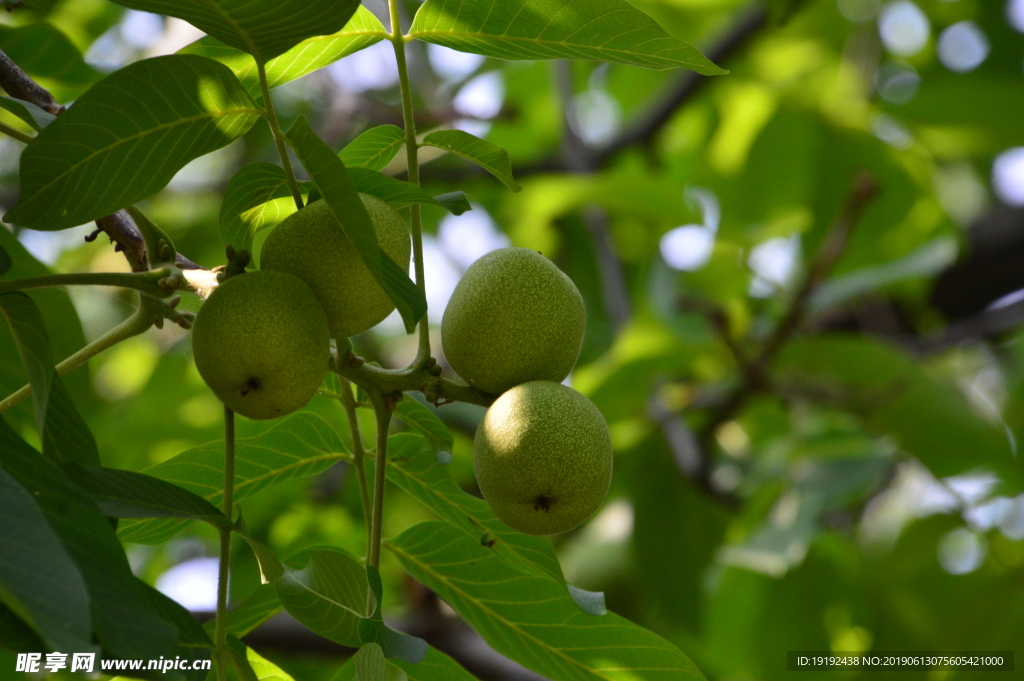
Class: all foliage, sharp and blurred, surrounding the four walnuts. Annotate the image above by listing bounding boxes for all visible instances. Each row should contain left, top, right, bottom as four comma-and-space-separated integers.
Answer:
0, 0, 1024, 681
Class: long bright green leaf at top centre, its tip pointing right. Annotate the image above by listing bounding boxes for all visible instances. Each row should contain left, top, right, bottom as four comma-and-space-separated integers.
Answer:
410, 0, 727, 76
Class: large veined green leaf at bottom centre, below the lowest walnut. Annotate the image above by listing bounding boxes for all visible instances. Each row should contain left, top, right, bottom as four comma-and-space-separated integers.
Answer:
386, 521, 705, 681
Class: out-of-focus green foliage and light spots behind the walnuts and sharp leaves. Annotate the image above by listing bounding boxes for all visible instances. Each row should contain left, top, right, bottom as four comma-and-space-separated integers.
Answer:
0, 0, 1024, 680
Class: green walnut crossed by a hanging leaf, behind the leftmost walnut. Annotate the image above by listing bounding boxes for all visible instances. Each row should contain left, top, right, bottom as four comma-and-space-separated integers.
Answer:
260, 194, 411, 338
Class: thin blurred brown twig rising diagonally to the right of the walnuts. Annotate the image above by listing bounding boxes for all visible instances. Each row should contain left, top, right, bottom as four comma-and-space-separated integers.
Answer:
697, 172, 879, 454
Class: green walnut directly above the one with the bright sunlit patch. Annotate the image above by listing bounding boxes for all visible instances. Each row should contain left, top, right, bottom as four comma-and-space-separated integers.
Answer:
441, 248, 587, 395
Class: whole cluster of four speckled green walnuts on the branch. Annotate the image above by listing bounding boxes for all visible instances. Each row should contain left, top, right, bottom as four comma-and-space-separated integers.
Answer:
193, 195, 612, 535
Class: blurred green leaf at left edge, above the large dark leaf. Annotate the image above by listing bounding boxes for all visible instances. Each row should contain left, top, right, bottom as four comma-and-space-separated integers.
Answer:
0, 24, 101, 101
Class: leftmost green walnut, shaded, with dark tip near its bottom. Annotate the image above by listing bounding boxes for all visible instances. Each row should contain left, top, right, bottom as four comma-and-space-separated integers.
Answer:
191, 270, 331, 419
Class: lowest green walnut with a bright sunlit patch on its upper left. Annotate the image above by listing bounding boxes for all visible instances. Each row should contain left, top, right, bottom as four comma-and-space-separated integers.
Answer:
473, 381, 611, 535
